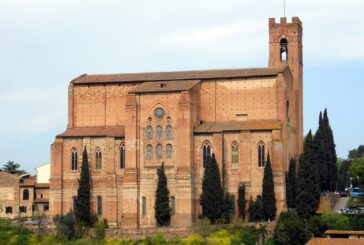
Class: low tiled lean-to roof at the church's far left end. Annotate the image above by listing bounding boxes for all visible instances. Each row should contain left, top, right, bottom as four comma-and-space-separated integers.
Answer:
57, 126, 125, 138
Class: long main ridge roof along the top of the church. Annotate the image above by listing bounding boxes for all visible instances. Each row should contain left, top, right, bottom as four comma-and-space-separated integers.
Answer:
72, 65, 288, 84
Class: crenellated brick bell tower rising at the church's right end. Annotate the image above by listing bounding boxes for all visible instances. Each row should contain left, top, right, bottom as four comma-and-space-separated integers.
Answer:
269, 17, 303, 157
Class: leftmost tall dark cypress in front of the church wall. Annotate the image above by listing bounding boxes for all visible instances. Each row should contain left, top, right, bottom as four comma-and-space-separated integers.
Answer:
75, 147, 92, 226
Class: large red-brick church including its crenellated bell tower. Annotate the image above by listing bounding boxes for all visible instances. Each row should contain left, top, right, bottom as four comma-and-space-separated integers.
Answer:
49, 17, 303, 228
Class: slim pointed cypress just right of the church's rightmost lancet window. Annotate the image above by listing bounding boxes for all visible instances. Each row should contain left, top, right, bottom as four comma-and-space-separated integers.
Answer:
262, 152, 277, 220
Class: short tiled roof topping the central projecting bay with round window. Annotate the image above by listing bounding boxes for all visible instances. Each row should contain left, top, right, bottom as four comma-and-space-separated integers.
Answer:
130, 80, 201, 93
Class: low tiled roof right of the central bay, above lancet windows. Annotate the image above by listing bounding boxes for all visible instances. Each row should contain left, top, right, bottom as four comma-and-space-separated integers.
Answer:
193, 120, 281, 133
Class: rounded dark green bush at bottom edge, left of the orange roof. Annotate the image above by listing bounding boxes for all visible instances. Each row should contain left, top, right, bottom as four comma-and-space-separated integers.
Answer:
273, 213, 308, 245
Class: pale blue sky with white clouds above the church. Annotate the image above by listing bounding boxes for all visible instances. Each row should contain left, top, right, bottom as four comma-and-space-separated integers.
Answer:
0, 0, 364, 171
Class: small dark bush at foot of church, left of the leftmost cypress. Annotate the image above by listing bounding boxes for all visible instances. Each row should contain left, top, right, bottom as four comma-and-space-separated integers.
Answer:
54, 212, 76, 240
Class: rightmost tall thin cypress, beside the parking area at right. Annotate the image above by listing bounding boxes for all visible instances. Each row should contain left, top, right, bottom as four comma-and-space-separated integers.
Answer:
323, 109, 337, 191
